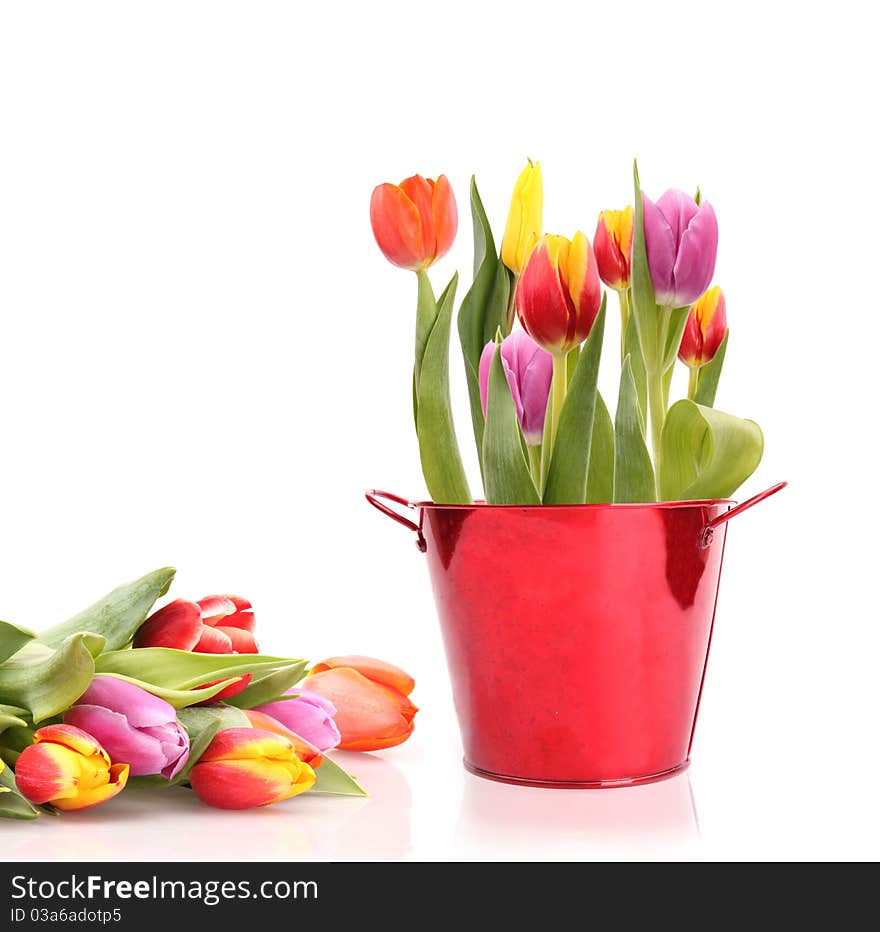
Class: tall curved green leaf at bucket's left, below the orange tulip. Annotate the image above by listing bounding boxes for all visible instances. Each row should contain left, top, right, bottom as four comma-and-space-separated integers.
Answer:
418, 273, 472, 505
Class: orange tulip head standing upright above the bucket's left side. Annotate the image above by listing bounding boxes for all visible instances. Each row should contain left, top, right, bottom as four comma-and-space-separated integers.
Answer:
370, 175, 458, 272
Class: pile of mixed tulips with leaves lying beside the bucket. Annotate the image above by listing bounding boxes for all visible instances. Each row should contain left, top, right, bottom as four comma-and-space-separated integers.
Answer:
0, 568, 417, 819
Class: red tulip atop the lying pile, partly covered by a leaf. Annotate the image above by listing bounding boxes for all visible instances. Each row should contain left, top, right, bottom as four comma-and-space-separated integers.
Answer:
134, 595, 258, 702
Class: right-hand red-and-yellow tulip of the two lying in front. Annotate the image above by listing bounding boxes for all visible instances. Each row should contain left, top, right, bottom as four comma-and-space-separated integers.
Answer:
189, 728, 315, 809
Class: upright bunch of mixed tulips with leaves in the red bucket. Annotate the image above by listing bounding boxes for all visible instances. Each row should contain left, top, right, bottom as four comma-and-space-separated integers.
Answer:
370, 162, 763, 505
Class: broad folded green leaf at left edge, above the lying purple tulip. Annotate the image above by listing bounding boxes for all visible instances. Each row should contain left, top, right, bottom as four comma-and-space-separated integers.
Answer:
0, 633, 104, 723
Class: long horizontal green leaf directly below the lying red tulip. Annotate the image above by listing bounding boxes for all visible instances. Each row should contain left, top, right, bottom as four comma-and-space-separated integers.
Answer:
95, 647, 298, 698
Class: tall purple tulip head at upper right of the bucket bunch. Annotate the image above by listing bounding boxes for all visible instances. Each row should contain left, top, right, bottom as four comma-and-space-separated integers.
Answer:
643, 191, 718, 307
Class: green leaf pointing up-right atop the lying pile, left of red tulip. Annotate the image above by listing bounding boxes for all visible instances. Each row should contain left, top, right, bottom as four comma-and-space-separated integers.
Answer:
39, 566, 175, 650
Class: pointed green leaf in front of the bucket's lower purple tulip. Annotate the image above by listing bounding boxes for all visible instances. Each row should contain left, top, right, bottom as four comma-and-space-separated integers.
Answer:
483, 341, 541, 505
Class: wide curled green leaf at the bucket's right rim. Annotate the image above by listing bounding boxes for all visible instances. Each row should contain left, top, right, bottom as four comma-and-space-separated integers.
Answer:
661, 398, 764, 501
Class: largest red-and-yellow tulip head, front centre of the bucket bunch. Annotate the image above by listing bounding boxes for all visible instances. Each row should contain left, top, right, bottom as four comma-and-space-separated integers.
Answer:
516, 232, 602, 356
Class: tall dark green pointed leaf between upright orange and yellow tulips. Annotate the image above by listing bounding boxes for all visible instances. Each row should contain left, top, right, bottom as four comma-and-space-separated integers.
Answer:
458, 177, 512, 469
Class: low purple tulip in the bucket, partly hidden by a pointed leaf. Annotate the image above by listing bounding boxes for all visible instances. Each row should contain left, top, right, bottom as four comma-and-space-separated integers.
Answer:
480, 330, 553, 447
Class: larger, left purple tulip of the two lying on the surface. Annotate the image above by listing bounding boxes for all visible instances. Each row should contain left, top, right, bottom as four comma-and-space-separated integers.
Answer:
64, 676, 189, 780
